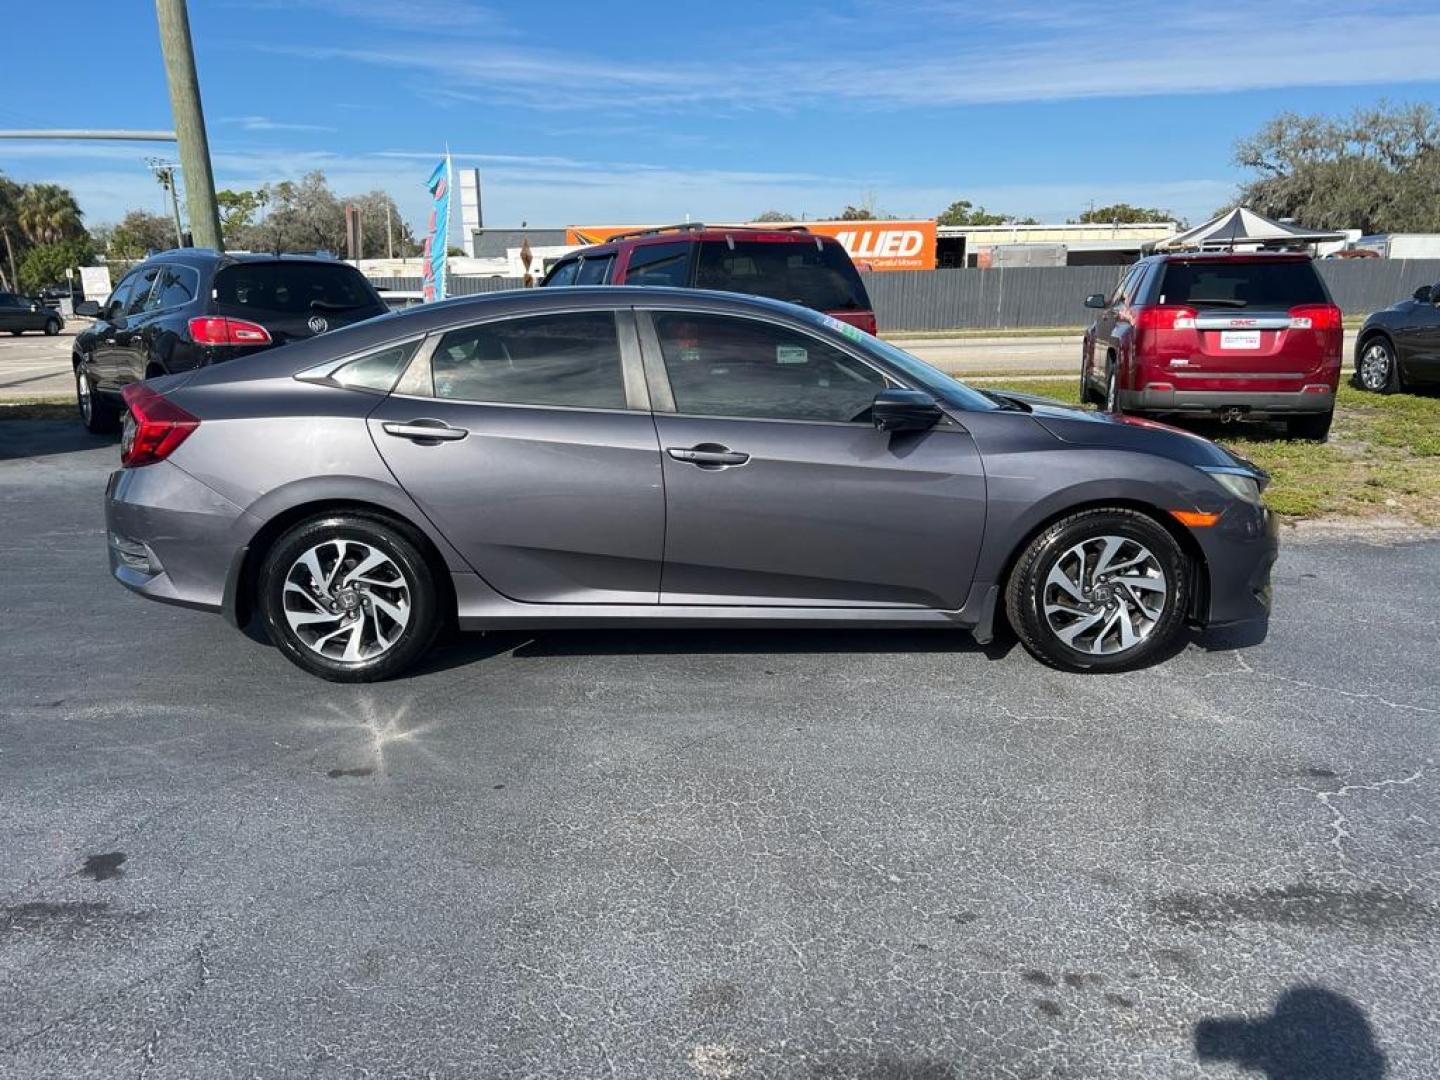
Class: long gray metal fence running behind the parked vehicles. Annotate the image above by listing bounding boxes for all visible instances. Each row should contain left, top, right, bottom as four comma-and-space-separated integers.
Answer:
374, 259, 1440, 331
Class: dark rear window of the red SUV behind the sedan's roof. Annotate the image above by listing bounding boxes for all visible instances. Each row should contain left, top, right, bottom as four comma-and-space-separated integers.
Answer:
696, 239, 870, 311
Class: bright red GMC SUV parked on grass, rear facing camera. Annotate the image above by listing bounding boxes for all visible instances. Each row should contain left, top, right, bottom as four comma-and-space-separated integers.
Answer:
1080, 252, 1344, 439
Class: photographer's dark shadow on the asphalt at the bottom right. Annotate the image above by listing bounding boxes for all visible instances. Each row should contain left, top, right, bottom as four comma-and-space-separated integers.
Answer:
1195, 985, 1385, 1080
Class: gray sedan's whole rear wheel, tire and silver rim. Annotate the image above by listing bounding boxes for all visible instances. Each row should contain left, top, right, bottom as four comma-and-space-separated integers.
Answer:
259, 514, 441, 683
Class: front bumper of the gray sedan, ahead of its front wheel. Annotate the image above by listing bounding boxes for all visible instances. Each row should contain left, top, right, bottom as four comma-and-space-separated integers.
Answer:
1192, 503, 1280, 641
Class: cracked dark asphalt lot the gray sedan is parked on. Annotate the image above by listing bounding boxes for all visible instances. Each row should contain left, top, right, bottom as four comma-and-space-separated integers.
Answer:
0, 422, 1440, 1080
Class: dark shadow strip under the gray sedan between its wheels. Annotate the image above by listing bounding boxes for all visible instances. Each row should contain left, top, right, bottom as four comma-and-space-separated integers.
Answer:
412, 626, 1015, 675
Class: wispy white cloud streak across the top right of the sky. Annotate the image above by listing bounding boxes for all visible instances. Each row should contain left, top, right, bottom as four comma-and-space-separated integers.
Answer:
268, 0, 1440, 111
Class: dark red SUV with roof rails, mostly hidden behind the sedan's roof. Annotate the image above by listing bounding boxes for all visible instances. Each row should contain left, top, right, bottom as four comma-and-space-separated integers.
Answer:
540, 223, 876, 334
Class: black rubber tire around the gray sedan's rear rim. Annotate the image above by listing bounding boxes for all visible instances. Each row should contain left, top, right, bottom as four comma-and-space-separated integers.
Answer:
258, 514, 441, 683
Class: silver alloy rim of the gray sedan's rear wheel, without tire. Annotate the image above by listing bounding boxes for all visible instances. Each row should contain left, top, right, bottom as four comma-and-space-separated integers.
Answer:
282, 540, 412, 662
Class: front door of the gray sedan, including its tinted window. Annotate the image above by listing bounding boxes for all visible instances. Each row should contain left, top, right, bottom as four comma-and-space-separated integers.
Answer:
638, 308, 985, 611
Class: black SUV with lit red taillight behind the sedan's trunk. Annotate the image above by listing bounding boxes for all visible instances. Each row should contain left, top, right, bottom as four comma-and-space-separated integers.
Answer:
71, 248, 387, 432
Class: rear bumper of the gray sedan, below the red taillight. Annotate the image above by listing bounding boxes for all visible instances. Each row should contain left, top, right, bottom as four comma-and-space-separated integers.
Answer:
105, 461, 255, 611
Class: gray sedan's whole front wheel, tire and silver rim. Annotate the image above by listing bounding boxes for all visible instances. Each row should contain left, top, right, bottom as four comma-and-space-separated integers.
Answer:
1005, 508, 1189, 671
